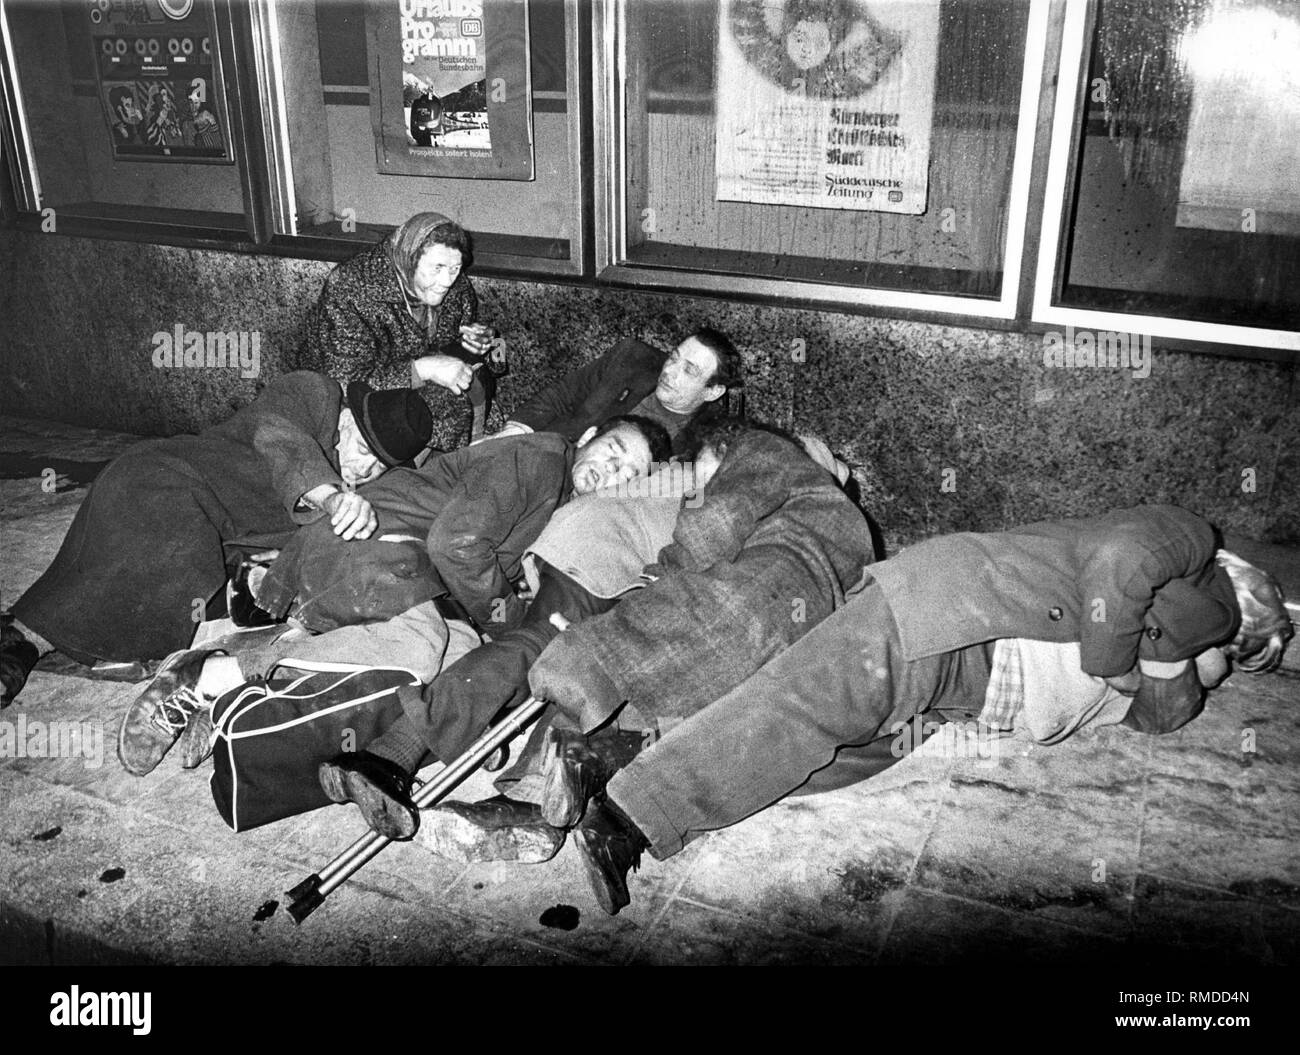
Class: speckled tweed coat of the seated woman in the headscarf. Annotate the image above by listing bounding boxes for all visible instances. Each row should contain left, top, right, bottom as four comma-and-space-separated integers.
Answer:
298, 242, 504, 451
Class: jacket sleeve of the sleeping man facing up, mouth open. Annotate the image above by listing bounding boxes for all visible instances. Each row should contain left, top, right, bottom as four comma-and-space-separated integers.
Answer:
428, 447, 563, 633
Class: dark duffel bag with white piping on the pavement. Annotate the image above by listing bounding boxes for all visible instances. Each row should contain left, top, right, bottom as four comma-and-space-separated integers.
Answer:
212, 660, 420, 832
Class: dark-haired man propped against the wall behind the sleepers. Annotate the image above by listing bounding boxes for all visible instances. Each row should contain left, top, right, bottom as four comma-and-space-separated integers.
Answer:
497, 329, 744, 455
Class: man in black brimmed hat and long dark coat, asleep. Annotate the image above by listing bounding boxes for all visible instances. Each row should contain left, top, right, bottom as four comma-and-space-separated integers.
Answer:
3, 372, 433, 703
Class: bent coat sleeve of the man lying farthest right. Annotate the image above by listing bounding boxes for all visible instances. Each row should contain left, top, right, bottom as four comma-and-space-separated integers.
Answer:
1079, 507, 1216, 677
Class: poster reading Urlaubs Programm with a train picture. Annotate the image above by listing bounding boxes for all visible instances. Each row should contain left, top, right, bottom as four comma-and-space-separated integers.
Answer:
365, 0, 533, 179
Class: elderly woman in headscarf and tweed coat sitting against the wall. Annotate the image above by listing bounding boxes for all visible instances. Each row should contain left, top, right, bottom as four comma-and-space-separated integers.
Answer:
296, 213, 504, 451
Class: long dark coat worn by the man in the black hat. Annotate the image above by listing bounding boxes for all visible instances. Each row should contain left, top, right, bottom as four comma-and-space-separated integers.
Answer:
13, 373, 353, 663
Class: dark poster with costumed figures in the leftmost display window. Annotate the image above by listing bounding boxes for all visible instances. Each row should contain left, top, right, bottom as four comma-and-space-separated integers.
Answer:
86, 0, 234, 164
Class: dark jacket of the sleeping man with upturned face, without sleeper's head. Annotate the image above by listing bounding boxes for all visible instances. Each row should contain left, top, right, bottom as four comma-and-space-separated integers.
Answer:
257, 433, 576, 631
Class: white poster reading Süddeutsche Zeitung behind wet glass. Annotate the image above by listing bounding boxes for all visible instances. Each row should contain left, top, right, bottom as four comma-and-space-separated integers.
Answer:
716, 0, 940, 214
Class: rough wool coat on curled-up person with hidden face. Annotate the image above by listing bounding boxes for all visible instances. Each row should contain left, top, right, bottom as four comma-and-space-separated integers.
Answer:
529, 431, 872, 729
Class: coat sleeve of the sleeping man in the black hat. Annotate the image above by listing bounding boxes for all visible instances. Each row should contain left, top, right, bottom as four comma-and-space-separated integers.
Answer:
252, 373, 343, 524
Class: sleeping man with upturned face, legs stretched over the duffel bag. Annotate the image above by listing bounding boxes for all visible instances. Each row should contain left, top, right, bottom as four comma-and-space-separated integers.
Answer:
111, 417, 668, 776
